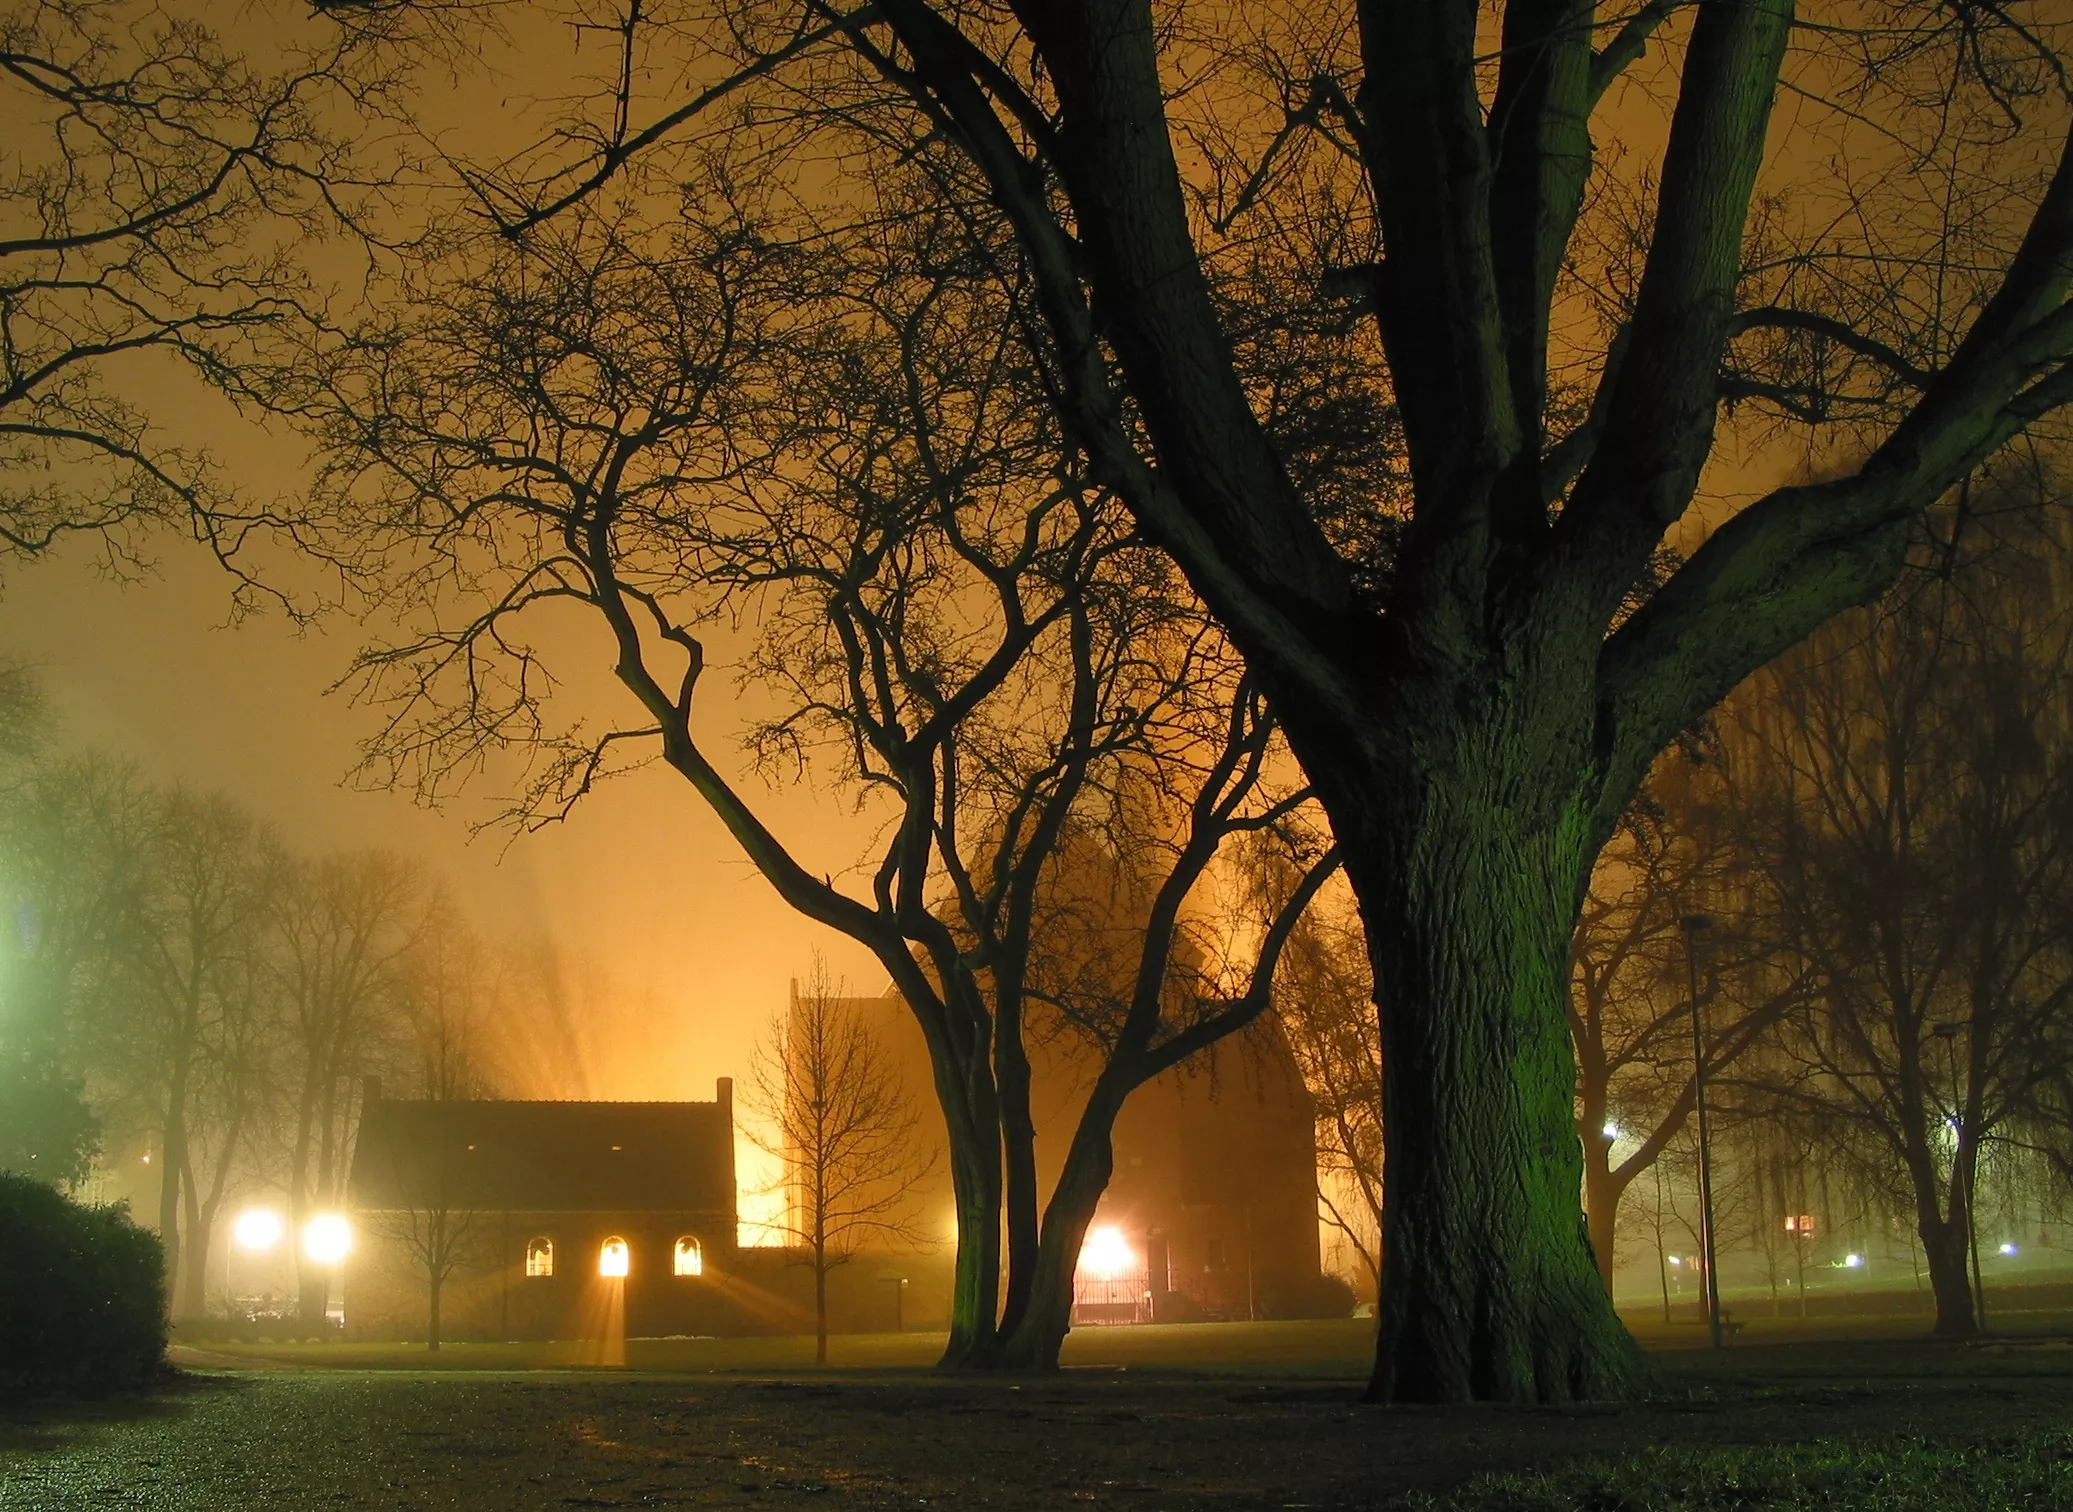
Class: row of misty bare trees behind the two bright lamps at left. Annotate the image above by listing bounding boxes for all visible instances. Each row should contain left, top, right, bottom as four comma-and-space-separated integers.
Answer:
0, 717, 505, 1321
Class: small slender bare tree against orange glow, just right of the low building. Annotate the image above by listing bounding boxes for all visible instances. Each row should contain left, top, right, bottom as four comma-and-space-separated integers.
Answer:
748, 960, 927, 1365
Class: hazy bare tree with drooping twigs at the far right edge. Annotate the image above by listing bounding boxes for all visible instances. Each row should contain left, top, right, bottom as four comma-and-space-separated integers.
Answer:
1727, 481, 2073, 1336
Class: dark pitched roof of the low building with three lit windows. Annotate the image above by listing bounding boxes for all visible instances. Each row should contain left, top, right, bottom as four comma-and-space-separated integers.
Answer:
348, 1091, 734, 1213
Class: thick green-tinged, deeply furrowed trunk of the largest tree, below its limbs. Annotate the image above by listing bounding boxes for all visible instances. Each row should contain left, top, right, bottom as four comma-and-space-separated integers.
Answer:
1306, 730, 1652, 1402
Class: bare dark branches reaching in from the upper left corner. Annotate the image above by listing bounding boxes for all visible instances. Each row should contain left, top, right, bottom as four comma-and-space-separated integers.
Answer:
0, 0, 386, 564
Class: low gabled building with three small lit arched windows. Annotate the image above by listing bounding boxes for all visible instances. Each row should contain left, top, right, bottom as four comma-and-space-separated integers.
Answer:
344, 1079, 755, 1340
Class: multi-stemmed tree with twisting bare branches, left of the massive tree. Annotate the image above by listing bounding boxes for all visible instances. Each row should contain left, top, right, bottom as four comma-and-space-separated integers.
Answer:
276, 185, 1329, 1365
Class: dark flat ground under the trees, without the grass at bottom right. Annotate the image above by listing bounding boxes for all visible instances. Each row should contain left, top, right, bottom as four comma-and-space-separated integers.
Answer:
12, 1321, 2073, 1512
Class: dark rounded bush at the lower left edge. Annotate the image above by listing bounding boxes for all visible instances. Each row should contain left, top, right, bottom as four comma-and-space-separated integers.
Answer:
0, 1172, 166, 1396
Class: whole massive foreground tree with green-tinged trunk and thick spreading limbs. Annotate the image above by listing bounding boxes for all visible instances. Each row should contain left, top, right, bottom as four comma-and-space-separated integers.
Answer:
352, 0, 2073, 1400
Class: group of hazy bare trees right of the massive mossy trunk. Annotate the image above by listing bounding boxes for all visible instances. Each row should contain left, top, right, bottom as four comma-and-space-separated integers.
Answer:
1571, 472, 2073, 1334
